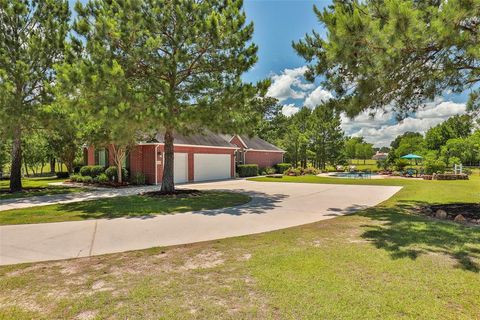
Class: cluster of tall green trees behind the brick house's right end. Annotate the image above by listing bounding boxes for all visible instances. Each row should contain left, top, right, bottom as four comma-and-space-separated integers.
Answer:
256, 104, 375, 170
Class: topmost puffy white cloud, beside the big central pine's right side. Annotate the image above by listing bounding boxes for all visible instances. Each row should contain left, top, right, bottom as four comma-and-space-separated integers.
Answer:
267, 66, 314, 102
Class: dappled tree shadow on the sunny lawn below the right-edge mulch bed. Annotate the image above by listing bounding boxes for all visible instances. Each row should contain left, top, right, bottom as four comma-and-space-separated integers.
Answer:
356, 202, 480, 273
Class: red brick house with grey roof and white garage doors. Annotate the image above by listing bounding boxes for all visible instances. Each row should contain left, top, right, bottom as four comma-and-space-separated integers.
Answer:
85, 133, 284, 184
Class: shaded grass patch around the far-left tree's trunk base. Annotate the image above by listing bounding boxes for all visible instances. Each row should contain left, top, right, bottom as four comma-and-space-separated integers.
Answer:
0, 177, 85, 200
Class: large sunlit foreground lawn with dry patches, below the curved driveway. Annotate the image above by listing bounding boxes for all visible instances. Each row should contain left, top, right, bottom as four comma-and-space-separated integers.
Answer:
0, 174, 480, 319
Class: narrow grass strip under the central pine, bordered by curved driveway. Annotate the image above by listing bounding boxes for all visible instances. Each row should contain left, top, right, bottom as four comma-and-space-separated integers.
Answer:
0, 191, 250, 225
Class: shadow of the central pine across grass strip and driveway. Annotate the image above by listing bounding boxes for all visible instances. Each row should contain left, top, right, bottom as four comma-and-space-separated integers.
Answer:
58, 190, 286, 219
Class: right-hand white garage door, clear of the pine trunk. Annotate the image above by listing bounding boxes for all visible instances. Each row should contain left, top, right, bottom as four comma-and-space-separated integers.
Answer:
194, 153, 231, 181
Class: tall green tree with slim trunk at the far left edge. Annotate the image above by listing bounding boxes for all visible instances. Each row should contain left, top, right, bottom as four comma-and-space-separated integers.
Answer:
0, 0, 70, 192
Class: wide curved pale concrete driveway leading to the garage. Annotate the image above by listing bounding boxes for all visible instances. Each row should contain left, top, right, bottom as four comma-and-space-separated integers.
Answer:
0, 180, 400, 265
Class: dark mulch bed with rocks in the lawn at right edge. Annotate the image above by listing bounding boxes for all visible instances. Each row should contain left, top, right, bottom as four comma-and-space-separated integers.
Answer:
421, 203, 480, 224
